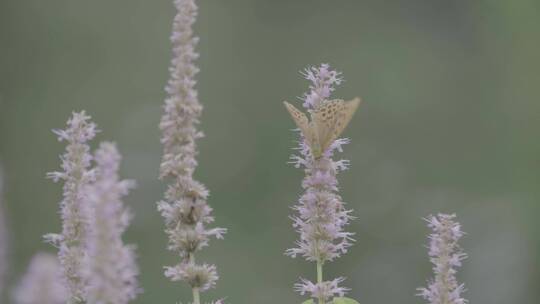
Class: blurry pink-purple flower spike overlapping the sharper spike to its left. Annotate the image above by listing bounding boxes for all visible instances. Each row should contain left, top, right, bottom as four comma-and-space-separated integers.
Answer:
83, 142, 139, 304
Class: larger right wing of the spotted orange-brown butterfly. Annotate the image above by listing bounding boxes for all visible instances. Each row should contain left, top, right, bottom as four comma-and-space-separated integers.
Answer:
312, 98, 360, 152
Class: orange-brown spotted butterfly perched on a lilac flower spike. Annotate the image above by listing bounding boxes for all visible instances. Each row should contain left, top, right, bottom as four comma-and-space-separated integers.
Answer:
284, 97, 360, 159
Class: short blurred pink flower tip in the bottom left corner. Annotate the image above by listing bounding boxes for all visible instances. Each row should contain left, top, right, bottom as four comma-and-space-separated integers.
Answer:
13, 253, 67, 304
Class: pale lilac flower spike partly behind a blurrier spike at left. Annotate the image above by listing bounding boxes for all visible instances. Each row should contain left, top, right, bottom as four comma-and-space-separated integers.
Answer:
45, 111, 97, 304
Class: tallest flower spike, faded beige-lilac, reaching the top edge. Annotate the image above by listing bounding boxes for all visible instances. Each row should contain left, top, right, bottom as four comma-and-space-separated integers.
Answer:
158, 0, 226, 304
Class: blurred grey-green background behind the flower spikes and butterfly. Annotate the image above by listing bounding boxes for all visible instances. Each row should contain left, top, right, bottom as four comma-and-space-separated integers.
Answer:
0, 0, 540, 304
